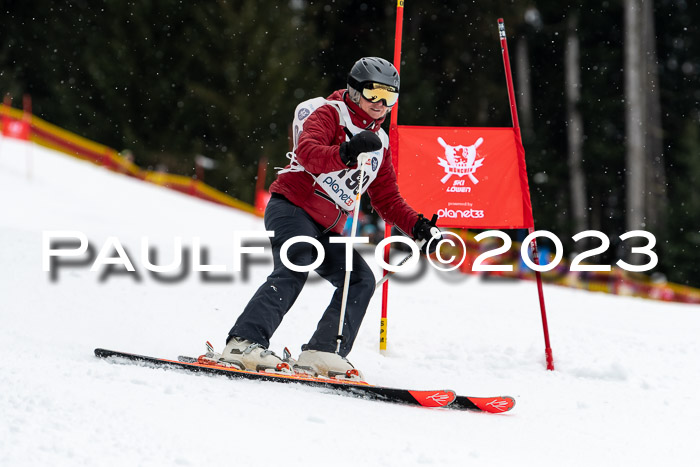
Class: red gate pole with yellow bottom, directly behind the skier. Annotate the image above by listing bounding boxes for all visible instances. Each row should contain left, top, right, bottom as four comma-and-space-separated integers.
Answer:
379, 0, 404, 352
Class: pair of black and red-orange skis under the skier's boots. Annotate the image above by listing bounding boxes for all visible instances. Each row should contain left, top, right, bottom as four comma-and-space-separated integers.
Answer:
95, 348, 515, 413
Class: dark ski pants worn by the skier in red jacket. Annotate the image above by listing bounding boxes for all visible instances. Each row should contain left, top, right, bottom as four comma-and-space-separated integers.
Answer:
229, 195, 376, 356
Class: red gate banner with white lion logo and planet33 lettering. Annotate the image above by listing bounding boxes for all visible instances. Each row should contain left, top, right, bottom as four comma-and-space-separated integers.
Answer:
398, 125, 533, 229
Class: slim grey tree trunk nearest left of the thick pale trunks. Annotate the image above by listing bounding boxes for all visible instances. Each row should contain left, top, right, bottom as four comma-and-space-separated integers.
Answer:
565, 12, 588, 243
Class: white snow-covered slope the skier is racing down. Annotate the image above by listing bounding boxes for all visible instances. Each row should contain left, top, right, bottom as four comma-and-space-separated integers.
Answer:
0, 139, 700, 467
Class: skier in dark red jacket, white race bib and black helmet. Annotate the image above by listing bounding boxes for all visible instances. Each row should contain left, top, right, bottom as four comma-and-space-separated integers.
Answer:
221, 57, 435, 380
